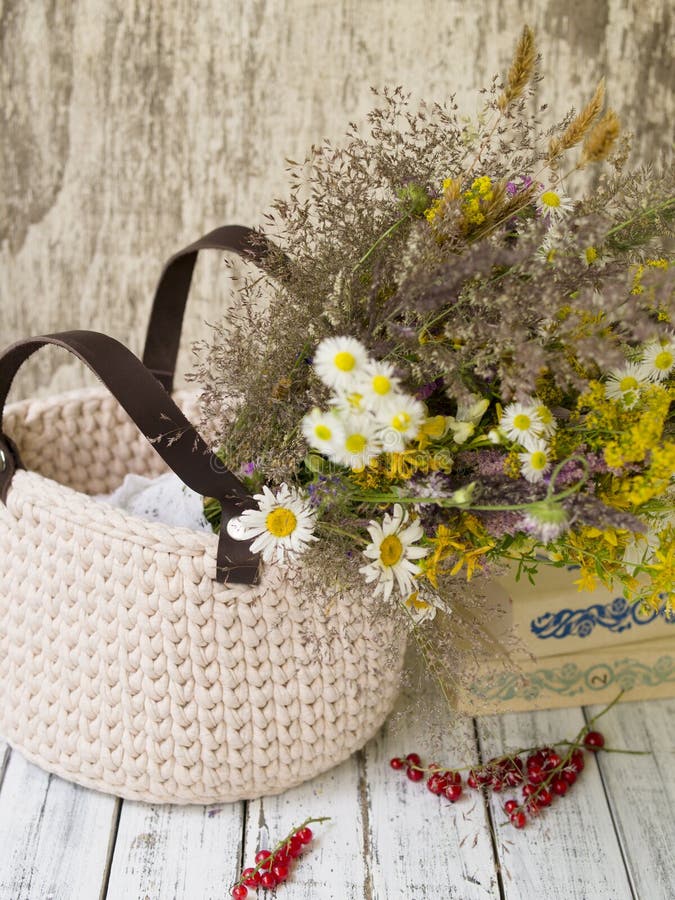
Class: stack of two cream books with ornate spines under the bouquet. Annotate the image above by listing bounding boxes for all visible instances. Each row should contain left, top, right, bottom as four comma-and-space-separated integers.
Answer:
457, 569, 675, 714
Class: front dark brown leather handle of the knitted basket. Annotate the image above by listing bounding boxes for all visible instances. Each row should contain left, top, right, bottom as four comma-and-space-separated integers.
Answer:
0, 331, 259, 584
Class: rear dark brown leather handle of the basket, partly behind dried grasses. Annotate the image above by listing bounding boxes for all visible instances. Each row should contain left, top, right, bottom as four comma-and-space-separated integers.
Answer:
143, 225, 276, 393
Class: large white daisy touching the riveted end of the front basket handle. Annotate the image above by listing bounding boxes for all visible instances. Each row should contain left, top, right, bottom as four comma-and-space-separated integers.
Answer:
239, 484, 317, 566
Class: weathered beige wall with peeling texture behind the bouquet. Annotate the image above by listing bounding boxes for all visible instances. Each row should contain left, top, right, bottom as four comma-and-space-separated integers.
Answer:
0, 0, 674, 397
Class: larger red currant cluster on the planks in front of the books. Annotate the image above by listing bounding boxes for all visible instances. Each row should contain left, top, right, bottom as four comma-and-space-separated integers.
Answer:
389, 729, 605, 828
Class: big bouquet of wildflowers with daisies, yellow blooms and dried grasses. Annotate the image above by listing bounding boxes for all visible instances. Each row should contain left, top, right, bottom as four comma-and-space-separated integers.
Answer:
196, 28, 675, 622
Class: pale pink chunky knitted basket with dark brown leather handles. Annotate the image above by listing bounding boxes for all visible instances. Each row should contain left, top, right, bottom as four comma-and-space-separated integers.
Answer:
0, 229, 403, 803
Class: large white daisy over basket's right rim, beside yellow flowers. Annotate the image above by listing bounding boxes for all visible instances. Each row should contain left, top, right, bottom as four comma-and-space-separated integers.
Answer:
359, 503, 429, 600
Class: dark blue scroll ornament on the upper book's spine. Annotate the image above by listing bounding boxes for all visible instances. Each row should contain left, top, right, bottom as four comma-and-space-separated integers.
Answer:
530, 597, 675, 640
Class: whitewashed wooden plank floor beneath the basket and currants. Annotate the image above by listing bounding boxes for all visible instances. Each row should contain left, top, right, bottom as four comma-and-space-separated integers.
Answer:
0, 697, 675, 900
